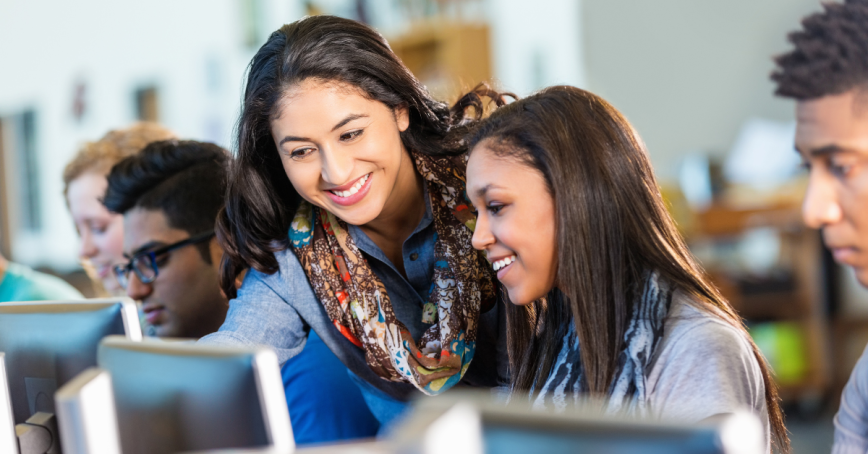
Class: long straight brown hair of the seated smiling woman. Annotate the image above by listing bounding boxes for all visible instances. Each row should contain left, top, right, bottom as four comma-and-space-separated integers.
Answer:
468, 86, 790, 452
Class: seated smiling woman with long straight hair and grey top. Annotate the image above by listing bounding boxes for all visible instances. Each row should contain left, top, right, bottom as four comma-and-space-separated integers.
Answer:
467, 86, 789, 452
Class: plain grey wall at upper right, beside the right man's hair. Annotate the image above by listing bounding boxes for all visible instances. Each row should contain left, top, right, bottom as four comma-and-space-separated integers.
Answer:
584, 0, 820, 179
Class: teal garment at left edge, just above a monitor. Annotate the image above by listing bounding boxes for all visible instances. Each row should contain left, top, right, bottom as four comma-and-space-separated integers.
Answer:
0, 262, 84, 303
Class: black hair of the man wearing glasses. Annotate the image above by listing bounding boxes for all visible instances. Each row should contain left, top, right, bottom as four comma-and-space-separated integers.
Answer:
103, 140, 230, 263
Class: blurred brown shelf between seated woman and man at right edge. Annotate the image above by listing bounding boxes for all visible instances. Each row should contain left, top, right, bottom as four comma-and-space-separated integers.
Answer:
687, 203, 836, 405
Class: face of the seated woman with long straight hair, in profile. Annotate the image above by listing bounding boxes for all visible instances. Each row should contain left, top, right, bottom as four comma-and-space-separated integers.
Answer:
467, 141, 558, 305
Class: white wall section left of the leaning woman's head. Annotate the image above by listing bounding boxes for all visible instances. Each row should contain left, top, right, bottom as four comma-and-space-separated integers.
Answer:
0, 0, 301, 269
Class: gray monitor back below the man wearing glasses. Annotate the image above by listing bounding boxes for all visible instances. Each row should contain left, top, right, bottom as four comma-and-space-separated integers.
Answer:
98, 337, 294, 454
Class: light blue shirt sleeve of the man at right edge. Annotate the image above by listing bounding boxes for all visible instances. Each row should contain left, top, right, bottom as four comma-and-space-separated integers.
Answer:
832, 342, 868, 454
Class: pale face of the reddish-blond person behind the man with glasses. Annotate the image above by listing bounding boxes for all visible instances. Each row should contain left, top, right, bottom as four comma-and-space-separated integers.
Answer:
66, 172, 124, 295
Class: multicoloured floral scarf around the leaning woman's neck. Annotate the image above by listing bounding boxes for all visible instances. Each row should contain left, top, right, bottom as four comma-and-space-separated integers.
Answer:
289, 154, 495, 395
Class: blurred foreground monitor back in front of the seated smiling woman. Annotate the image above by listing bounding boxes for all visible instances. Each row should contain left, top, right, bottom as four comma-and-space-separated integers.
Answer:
395, 390, 764, 454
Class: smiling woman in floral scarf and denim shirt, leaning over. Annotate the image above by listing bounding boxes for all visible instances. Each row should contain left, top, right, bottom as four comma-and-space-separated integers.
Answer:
203, 16, 507, 430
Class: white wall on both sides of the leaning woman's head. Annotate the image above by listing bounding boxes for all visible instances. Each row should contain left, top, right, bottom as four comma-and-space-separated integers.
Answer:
0, 0, 585, 270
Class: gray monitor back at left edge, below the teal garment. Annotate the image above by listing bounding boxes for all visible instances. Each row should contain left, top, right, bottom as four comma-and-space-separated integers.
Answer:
0, 298, 142, 424
